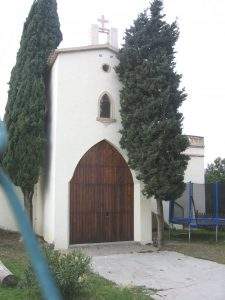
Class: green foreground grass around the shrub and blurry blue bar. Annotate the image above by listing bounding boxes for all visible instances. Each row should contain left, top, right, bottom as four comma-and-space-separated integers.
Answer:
0, 230, 153, 300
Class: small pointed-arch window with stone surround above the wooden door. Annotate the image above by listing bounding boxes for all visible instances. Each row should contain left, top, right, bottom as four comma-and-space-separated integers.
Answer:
97, 91, 116, 123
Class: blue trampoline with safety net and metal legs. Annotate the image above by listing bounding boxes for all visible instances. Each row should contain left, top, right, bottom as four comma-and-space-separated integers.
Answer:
169, 182, 225, 241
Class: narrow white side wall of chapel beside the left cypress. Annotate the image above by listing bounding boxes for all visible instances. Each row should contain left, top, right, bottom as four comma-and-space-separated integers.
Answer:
37, 56, 58, 243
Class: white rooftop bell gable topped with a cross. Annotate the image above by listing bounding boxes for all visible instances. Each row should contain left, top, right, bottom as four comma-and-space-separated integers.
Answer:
91, 15, 118, 49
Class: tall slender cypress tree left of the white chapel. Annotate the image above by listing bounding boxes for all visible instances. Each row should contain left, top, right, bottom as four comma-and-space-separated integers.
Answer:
3, 0, 62, 220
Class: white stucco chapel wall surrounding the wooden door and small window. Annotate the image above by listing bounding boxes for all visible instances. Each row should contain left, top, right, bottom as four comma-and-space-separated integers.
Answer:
44, 49, 151, 248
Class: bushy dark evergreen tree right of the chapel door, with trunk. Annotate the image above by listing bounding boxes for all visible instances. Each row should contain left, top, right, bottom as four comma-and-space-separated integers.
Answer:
116, 0, 188, 247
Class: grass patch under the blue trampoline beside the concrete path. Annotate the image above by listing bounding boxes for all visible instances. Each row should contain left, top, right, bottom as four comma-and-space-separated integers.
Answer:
163, 229, 225, 264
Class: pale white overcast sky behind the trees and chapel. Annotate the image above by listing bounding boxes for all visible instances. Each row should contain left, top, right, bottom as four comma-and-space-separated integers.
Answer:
0, 0, 225, 163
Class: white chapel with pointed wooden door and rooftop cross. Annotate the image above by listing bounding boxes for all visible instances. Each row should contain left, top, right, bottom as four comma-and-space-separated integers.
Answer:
0, 18, 204, 249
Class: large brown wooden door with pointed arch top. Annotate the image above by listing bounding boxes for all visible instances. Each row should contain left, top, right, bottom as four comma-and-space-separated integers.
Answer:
70, 141, 134, 244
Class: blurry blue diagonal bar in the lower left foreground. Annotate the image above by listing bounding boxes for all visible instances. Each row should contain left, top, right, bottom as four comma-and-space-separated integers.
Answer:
0, 168, 62, 300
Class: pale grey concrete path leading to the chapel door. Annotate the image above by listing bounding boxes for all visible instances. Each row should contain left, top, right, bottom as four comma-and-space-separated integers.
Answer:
93, 251, 225, 300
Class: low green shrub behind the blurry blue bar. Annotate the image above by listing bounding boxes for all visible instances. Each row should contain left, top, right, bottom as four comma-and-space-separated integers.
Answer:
20, 247, 91, 299
